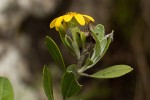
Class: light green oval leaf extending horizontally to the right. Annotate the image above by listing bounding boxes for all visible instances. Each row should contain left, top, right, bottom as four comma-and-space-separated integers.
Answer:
90, 65, 133, 78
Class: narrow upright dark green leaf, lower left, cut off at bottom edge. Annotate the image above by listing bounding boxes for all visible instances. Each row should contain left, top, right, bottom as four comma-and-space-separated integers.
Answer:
42, 65, 54, 100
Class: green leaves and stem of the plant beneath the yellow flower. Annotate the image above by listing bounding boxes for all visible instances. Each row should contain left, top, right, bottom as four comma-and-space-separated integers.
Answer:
43, 12, 133, 100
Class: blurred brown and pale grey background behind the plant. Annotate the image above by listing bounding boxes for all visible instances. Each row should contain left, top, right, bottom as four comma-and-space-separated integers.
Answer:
0, 0, 150, 100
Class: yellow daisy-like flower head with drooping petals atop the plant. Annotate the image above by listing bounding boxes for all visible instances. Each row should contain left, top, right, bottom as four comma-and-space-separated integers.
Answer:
50, 12, 94, 29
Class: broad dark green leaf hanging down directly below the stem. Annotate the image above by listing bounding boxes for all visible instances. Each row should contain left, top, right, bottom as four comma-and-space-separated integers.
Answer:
61, 72, 82, 99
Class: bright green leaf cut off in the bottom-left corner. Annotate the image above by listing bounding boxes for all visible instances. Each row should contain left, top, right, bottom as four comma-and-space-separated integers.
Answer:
0, 77, 14, 100
